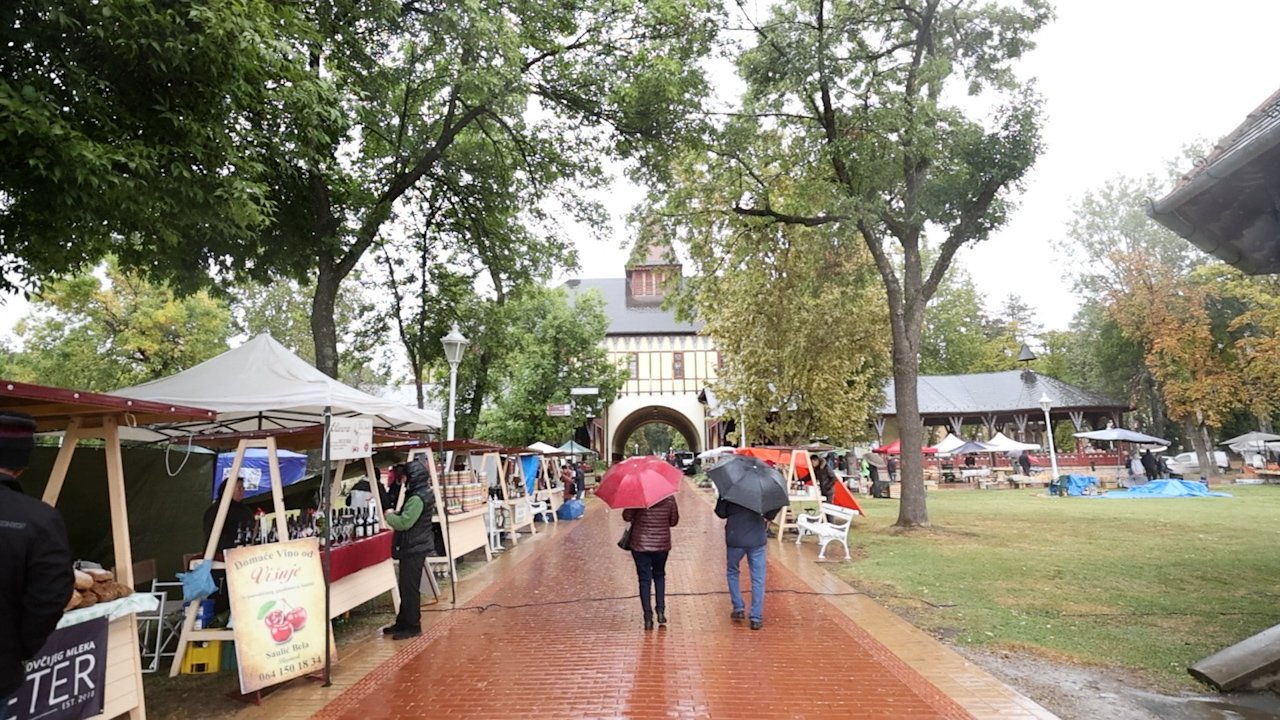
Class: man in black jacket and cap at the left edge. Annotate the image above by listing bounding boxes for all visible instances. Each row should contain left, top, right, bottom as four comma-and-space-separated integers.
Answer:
0, 413, 76, 717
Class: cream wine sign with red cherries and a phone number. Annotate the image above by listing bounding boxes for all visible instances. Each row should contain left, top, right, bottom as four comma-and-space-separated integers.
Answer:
225, 538, 328, 694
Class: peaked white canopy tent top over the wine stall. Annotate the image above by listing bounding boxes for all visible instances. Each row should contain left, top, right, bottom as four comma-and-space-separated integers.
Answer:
114, 333, 440, 439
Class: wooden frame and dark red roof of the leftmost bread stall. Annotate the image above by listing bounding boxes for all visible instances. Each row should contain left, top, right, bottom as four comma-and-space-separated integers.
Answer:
0, 380, 216, 720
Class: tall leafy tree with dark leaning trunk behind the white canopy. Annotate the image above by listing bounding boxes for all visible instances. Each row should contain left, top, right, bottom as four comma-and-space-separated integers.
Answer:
256, 0, 714, 374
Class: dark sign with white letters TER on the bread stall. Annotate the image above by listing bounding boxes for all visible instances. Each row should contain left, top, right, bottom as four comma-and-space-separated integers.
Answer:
9, 618, 109, 720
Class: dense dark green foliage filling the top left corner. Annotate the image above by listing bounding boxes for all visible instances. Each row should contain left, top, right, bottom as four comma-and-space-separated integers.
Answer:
0, 0, 337, 290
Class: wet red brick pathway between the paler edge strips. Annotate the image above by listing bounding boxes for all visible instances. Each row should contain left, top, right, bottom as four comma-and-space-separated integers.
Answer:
315, 486, 972, 720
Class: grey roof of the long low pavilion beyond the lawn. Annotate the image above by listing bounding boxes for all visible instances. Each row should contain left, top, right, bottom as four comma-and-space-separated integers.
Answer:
881, 370, 1129, 416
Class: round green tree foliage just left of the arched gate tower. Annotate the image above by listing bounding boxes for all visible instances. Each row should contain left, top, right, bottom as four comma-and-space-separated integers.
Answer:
476, 287, 626, 446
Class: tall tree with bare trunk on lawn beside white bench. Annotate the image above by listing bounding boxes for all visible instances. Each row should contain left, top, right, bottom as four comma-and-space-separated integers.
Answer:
660, 0, 1051, 527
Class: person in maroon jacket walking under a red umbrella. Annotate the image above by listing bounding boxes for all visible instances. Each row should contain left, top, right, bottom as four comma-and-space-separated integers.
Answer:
595, 457, 684, 630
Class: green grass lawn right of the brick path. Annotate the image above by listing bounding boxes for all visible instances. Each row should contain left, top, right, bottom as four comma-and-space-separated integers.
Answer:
837, 486, 1280, 689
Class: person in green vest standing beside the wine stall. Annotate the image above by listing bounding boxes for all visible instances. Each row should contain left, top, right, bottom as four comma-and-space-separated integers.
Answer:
383, 457, 435, 641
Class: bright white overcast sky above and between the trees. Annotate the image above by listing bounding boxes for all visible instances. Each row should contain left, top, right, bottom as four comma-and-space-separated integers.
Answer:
565, 0, 1280, 329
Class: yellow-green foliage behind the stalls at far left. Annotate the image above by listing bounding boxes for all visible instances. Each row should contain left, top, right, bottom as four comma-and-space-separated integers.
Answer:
0, 261, 230, 392
